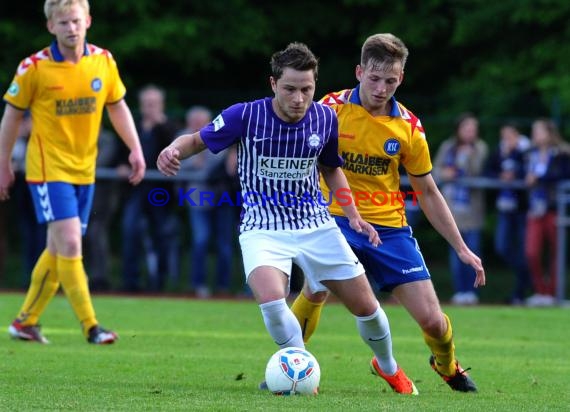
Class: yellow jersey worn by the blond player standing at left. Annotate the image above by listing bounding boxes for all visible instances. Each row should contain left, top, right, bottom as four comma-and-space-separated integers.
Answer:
4, 41, 126, 184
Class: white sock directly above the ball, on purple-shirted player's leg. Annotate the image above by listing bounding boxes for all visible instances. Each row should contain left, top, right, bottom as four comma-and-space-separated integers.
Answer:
259, 299, 305, 348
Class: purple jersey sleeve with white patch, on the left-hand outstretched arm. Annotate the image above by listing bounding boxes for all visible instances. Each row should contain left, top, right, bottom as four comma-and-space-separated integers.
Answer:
200, 103, 246, 153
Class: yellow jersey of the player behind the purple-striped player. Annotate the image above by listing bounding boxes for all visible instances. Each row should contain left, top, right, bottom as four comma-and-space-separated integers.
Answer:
320, 86, 432, 227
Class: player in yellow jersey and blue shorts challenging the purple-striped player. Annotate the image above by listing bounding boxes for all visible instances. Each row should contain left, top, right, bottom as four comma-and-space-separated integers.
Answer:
292, 34, 485, 392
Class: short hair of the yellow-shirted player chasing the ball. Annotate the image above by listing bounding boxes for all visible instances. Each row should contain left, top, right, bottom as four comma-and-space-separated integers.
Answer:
360, 33, 409, 70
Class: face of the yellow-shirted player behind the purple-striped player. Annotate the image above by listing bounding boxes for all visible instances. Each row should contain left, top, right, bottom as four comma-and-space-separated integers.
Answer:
356, 62, 404, 115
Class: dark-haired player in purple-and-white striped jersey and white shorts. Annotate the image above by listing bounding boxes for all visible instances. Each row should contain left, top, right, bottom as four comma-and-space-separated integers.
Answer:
157, 43, 417, 394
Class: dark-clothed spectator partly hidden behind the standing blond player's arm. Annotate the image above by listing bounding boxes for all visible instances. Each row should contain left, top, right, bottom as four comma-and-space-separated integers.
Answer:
84, 128, 119, 292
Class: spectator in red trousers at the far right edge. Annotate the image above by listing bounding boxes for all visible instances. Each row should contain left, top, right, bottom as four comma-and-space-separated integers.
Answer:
525, 118, 570, 306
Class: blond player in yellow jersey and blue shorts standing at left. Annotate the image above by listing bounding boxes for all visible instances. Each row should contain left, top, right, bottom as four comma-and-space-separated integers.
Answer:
0, 0, 146, 344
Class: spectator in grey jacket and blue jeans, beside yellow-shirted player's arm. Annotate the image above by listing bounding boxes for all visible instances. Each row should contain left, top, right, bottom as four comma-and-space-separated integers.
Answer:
434, 113, 488, 305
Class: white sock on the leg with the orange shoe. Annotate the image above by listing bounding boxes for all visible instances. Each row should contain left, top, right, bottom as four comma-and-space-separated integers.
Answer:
355, 304, 398, 375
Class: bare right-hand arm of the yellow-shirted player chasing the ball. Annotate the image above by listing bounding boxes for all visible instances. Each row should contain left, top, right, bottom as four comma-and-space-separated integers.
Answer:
408, 174, 485, 287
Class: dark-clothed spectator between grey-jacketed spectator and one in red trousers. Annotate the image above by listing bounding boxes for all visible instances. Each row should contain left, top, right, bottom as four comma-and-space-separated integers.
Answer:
487, 122, 532, 305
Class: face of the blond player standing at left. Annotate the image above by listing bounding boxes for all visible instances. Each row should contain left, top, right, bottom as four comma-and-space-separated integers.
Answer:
47, 4, 91, 50
